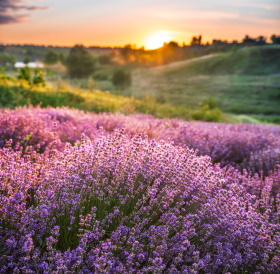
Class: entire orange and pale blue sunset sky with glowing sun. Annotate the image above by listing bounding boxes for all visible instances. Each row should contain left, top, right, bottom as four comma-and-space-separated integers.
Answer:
0, 0, 280, 48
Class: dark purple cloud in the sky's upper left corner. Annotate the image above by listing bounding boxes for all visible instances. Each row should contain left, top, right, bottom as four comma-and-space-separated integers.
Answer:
0, 0, 48, 25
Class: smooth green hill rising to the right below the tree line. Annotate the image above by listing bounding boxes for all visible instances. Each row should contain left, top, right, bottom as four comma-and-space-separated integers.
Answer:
152, 45, 280, 75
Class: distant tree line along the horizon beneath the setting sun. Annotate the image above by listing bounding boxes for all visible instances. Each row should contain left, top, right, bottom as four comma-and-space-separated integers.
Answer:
0, 34, 280, 69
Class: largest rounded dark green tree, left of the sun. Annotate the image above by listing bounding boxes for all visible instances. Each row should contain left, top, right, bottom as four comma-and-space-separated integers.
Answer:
66, 45, 95, 78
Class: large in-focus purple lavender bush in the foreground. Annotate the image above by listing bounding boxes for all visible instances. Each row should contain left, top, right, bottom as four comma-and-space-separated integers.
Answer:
0, 124, 280, 273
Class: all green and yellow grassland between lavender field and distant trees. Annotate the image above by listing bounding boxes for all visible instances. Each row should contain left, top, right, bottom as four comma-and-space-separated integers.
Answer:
3, 45, 280, 124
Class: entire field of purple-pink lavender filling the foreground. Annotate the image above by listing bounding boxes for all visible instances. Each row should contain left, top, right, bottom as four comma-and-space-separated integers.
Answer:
0, 108, 280, 274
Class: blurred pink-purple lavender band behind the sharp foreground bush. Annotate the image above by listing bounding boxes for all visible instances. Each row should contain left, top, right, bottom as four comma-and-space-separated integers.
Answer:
0, 108, 280, 175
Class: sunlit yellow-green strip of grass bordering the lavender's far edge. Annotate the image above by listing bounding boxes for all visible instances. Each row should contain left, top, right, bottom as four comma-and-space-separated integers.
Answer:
0, 73, 223, 122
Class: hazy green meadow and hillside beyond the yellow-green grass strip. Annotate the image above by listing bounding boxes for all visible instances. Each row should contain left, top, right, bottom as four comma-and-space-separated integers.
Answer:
43, 45, 280, 124
